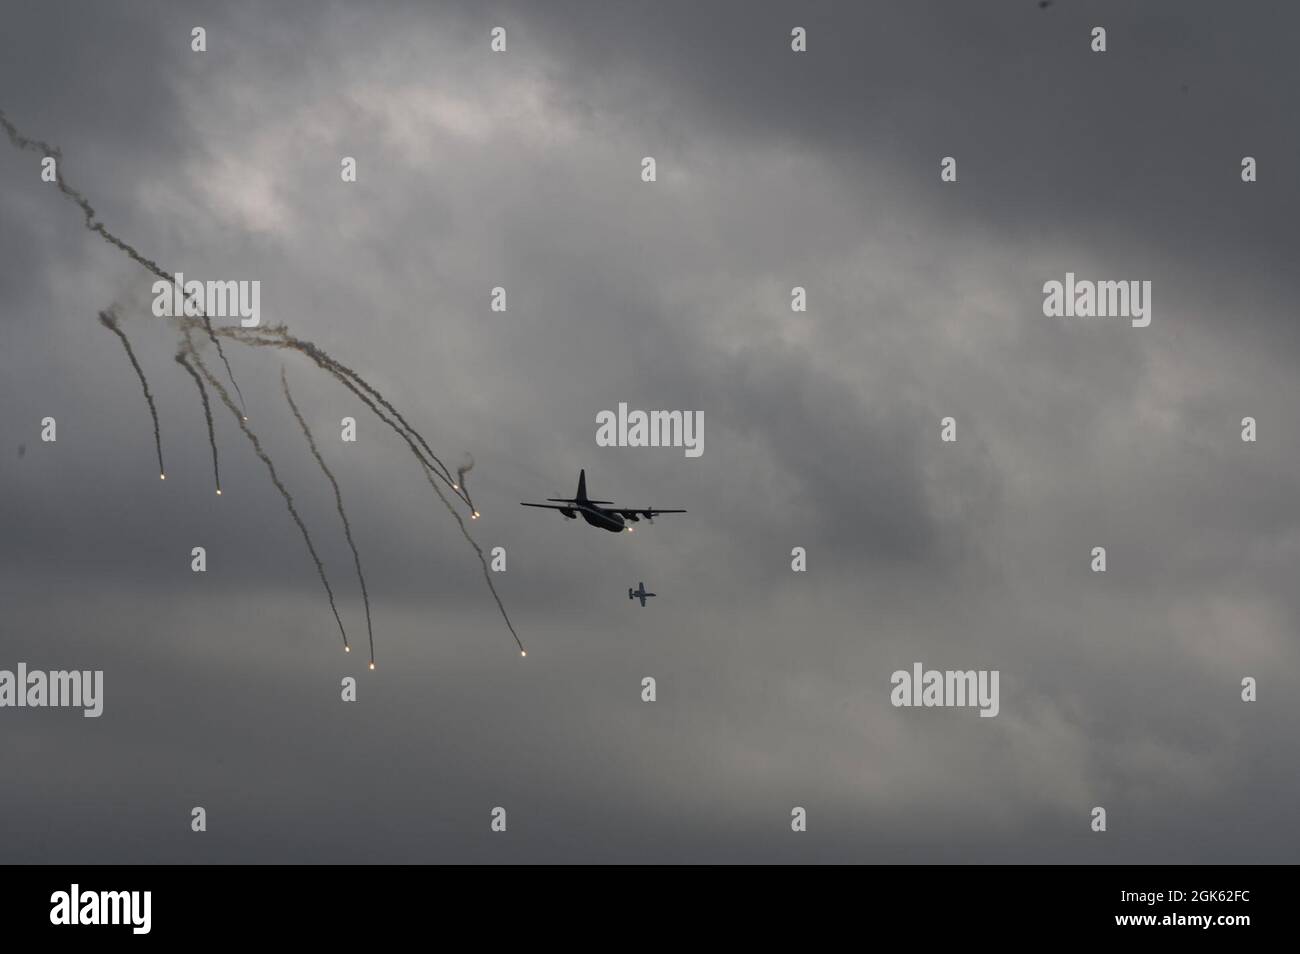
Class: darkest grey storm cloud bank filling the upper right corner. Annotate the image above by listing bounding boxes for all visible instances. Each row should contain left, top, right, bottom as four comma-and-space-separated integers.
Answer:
514, 0, 1300, 264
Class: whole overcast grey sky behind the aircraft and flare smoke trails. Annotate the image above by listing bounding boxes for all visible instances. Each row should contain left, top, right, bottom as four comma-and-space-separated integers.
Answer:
0, 0, 1300, 863
